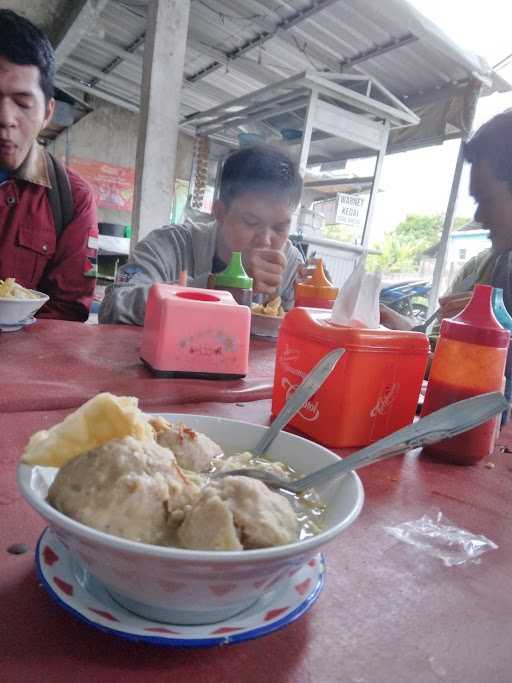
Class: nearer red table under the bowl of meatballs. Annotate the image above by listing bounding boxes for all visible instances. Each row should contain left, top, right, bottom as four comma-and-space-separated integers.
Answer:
0, 400, 512, 683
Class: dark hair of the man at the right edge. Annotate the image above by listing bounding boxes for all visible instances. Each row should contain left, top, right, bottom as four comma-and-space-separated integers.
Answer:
464, 109, 512, 187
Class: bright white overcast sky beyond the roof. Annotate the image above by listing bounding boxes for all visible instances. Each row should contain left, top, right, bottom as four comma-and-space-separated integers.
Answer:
358, 0, 512, 243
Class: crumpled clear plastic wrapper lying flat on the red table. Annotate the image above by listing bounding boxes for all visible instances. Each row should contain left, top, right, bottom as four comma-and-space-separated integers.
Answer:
384, 512, 498, 567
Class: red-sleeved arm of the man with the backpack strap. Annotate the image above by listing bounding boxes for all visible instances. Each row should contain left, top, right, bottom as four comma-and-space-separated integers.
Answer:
38, 172, 98, 321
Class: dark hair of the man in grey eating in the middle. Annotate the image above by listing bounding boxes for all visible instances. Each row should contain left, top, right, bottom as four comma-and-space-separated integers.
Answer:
219, 145, 302, 207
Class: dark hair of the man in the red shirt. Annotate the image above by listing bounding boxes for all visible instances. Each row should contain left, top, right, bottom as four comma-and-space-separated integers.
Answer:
0, 9, 55, 102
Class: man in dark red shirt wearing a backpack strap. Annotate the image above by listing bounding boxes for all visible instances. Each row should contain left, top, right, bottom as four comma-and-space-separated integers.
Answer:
0, 10, 98, 320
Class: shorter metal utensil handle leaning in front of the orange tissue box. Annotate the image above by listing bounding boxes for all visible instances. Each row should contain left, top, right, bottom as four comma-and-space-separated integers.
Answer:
251, 349, 345, 456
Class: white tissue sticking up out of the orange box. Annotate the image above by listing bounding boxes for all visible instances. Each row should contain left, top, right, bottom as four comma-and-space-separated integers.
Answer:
331, 257, 381, 329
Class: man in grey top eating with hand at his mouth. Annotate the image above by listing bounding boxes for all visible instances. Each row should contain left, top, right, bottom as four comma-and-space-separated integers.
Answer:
99, 145, 302, 325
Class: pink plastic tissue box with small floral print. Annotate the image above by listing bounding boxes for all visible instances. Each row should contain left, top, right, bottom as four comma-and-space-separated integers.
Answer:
140, 284, 251, 379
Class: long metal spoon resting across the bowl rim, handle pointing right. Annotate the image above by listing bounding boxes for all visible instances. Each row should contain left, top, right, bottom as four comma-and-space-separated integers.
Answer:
215, 391, 508, 493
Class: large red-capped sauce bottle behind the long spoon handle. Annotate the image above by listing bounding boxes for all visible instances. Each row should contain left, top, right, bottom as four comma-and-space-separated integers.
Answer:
421, 285, 510, 465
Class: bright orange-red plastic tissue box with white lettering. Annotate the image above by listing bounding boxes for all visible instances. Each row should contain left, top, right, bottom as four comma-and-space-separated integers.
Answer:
272, 307, 428, 448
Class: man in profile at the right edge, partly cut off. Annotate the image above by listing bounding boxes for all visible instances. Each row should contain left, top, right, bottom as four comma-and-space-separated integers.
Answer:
381, 110, 512, 329
